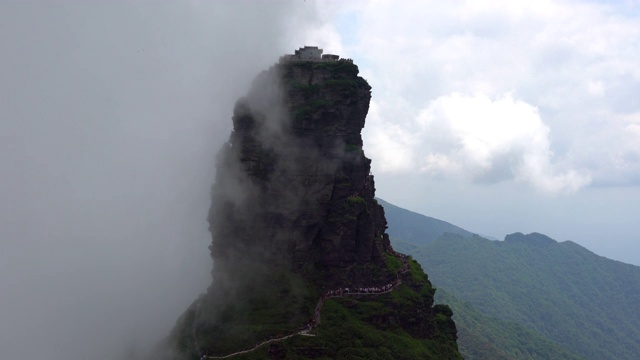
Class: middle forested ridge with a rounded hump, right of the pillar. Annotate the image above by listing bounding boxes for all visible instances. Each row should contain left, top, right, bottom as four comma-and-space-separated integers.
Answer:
414, 235, 640, 359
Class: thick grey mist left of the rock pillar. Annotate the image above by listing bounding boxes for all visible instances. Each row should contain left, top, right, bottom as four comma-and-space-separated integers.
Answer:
0, 1, 322, 359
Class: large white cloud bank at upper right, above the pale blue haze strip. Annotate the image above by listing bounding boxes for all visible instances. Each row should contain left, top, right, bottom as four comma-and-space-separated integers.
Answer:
338, 0, 640, 192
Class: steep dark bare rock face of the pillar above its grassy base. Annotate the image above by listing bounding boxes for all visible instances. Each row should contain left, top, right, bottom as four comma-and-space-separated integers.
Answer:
209, 62, 392, 292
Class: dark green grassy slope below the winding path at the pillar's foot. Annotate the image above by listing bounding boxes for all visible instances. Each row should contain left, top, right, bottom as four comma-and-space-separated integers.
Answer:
208, 256, 462, 360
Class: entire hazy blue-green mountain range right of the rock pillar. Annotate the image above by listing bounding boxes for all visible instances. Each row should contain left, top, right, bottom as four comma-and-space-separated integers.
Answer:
379, 200, 640, 360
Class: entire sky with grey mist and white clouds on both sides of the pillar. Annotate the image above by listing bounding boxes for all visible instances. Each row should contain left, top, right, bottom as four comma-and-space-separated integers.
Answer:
0, 0, 640, 359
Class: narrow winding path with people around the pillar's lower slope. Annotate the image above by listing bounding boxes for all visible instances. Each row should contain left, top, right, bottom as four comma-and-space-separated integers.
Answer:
201, 252, 409, 360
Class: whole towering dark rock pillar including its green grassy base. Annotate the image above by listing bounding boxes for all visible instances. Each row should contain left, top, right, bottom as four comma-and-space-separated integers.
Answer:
157, 60, 461, 359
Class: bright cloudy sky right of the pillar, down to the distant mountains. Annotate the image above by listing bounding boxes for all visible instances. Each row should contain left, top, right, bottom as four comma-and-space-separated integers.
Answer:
312, 0, 640, 265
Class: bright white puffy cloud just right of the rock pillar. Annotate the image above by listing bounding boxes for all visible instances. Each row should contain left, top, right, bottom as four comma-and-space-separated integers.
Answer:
370, 93, 590, 192
